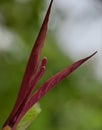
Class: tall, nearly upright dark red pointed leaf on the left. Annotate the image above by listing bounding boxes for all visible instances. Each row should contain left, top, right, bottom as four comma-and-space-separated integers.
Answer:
4, 0, 53, 126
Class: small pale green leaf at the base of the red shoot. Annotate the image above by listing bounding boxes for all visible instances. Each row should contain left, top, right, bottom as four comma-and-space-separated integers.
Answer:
17, 103, 41, 130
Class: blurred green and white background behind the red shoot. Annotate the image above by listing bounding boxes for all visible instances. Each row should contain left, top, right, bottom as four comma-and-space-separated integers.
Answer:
0, 0, 102, 130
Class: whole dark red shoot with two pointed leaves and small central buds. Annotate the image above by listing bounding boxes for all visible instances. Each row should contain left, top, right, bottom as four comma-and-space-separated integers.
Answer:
3, 0, 96, 130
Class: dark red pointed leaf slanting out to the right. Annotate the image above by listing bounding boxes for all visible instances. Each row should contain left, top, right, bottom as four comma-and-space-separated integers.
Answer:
21, 51, 97, 115
